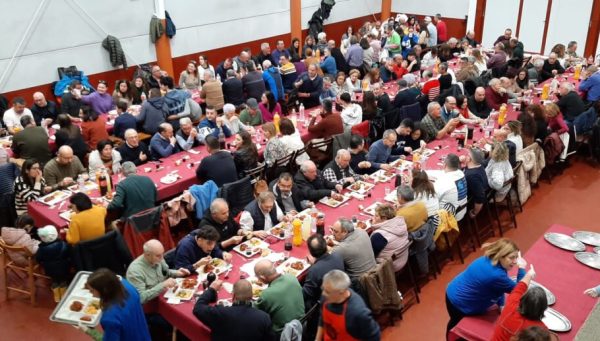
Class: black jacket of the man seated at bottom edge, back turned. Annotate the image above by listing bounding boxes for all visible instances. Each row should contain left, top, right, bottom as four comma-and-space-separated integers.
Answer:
194, 288, 273, 341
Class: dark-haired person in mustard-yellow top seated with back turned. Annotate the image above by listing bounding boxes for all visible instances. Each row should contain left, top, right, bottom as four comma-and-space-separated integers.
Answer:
66, 192, 106, 245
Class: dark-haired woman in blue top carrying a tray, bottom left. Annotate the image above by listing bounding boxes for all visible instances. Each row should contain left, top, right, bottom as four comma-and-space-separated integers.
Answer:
78, 268, 150, 341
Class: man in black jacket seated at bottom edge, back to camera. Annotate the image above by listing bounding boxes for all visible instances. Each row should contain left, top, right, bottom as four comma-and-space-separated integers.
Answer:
193, 279, 273, 341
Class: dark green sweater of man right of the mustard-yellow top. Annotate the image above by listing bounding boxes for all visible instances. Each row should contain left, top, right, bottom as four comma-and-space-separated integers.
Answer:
107, 174, 157, 218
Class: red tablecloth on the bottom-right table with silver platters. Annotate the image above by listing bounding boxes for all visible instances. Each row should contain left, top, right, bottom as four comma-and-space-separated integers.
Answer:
450, 224, 600, 341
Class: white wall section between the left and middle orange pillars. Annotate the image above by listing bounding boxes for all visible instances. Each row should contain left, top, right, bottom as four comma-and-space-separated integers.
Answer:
166, 0, 290, 57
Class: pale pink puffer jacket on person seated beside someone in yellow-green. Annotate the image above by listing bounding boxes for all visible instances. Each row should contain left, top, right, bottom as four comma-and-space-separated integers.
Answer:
373, 217, 409, 272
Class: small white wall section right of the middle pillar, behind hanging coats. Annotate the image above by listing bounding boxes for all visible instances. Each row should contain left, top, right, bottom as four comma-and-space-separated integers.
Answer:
300, 0, 381, 30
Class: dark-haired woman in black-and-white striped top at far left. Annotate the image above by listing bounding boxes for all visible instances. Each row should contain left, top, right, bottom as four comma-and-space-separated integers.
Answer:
14, 159, 51, 216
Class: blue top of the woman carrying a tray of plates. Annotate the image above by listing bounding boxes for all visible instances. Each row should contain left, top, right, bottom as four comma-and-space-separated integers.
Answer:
100, 278, 151, 341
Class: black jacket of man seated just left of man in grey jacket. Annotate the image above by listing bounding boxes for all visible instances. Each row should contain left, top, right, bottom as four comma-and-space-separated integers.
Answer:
302, 253, 344, 310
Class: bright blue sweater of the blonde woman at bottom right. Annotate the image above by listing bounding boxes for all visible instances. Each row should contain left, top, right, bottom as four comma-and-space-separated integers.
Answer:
446, 256, 525, 315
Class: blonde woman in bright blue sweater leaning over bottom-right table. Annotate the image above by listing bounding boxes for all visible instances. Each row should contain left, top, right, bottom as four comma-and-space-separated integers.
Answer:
446, 238, 527, 335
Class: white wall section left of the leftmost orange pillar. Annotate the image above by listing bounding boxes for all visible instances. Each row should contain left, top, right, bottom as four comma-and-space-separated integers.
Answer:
0, 0, 156, 92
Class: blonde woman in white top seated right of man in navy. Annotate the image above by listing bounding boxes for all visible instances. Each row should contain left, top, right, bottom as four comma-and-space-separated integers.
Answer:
485, 142, 514, 201
